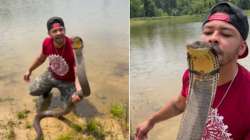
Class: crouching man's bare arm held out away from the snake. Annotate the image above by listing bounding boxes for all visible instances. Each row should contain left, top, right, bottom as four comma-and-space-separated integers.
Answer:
24, 53, 47, 82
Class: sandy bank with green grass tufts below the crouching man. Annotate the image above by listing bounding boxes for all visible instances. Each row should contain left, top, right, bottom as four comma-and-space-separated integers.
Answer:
0, 98, 128, 140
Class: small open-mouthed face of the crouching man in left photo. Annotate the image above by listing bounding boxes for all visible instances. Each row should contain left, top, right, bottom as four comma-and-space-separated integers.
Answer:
49, 26, 65, 45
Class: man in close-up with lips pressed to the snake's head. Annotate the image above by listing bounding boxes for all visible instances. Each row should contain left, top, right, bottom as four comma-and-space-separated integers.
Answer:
136, 2, 250, 140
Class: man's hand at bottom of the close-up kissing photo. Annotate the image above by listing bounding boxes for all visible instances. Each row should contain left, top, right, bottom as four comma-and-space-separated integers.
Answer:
135, 120, 154, 140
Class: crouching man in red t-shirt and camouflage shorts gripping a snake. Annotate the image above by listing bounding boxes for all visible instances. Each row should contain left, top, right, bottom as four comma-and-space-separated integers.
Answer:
24, 17, 80, 107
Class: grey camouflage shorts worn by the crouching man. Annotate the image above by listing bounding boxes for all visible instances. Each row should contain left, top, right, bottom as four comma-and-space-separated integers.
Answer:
29, 71, 76, 101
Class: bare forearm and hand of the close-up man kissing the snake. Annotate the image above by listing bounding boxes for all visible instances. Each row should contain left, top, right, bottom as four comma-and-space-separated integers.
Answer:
135, 95, 186, 140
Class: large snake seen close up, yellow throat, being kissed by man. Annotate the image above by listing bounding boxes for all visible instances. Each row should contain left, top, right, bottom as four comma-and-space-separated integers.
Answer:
177, 41, 221, 140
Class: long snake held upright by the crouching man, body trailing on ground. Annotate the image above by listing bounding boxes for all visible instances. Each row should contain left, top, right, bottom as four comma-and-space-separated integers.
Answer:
33, 37, 90, 140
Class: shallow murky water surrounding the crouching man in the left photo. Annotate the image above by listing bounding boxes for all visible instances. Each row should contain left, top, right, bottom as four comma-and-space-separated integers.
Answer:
0, 0, 129, 118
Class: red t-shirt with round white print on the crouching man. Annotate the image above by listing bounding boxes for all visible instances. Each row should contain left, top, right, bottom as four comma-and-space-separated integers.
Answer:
42, 36, 75, 82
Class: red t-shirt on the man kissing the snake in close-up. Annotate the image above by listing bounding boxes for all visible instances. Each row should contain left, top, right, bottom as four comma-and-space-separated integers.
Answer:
181, 64, 250, 140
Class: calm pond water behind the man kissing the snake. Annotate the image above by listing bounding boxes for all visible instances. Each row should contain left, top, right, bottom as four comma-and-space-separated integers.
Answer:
130, 19, 250, 140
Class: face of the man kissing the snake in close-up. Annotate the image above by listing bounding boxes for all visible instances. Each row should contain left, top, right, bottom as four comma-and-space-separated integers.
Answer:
201, 20, 246, 66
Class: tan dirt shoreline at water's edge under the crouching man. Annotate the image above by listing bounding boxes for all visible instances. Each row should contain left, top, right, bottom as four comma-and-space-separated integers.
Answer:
0, 98, 128, 140
